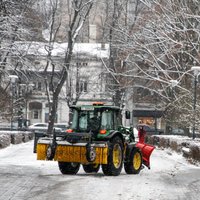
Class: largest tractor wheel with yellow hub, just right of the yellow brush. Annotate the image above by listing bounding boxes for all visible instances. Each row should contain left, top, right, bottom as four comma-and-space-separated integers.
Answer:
102, 136, 123, 176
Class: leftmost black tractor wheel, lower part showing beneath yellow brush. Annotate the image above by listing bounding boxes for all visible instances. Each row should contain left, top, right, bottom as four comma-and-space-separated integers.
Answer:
58, 162, 80, 174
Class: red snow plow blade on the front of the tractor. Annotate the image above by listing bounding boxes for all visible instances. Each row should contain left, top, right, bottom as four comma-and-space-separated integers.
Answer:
136, 142, 155, 169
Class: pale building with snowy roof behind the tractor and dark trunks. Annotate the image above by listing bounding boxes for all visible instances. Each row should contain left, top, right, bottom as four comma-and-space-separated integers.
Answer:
8, 42, 109, 124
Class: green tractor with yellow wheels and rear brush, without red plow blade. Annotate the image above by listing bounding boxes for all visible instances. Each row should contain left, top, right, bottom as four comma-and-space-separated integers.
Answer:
36, 103, 155, 176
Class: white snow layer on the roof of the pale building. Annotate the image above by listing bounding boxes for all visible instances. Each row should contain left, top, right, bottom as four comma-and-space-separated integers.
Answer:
15, 42, 109, 58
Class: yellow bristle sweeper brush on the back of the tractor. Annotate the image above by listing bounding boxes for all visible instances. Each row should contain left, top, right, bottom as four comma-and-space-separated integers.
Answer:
37, 143, 108, 164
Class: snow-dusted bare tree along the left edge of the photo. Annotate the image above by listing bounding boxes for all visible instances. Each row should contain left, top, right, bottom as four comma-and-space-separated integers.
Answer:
0, 0, 36, 122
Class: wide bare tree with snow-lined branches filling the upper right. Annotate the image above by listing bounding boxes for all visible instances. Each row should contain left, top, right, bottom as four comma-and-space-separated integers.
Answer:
104, 0, 200, 129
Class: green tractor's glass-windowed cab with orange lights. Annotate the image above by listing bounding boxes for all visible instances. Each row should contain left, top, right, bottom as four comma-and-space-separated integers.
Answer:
67, 104, 122, 139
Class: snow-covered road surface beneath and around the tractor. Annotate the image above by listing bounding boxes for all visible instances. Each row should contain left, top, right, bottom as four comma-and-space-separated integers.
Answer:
0, 141, 200, 200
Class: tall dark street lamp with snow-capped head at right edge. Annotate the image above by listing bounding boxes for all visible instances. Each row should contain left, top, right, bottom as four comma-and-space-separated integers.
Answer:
191, 66, 200, 140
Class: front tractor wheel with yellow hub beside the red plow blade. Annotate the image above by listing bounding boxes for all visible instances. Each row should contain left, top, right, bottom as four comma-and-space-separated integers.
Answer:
124, 148, 142, 174
